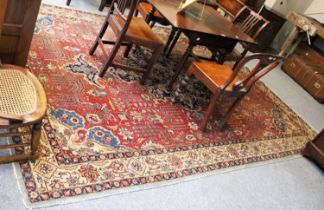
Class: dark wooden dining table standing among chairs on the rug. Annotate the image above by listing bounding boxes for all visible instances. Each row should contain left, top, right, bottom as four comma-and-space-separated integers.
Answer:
149, 0, 256, 89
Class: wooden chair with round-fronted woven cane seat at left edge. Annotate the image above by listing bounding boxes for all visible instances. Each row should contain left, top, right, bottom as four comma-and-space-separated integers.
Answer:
0, 63, 47, 163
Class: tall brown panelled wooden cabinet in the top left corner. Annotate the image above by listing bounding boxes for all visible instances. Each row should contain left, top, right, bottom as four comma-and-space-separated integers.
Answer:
0, 0, 41, 66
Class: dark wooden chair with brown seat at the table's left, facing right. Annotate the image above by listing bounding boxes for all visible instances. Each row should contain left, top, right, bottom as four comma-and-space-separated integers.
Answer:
89, 0, 163, 84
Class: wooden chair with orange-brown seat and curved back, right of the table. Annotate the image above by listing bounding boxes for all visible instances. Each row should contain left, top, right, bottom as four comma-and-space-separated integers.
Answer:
176, 53, 282, 131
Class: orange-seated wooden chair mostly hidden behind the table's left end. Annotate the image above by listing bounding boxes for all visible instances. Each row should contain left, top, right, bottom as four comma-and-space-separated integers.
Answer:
136, 1, 181, 56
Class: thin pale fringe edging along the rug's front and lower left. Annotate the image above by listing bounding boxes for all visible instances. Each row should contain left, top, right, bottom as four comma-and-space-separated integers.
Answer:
12, 154, 303, 209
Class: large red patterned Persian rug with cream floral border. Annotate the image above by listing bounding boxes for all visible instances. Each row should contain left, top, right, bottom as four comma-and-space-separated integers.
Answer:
17, 5, 315, 208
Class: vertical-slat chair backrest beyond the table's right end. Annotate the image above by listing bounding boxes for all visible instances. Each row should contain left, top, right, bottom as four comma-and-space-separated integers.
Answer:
233, 6, 270, 39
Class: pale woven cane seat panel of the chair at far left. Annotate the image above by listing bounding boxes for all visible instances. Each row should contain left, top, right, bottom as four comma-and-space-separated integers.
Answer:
0, 69, 38, 116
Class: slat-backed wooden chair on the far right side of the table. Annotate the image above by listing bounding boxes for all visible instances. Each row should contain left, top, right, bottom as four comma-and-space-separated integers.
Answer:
211, 6, 270, 65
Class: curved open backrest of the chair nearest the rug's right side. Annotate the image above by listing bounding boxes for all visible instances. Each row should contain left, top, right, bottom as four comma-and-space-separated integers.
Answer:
221, 53, 283, 92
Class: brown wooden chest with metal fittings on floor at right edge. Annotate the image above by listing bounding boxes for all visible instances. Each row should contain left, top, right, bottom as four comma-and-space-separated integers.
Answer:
282, 43, 324, 103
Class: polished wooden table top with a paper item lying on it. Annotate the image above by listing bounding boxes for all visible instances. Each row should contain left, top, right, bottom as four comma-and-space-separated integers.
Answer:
150, 0, 256, 44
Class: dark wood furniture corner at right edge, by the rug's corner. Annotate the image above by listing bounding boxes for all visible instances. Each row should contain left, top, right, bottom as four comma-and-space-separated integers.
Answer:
303, 130, 324, 170
